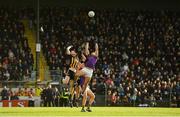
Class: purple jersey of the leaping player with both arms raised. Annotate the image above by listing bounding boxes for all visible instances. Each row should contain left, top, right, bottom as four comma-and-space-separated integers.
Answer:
85, 56, 97, 69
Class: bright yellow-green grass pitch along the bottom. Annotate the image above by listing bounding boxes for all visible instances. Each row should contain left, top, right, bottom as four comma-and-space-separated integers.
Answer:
0, 107, 180, 117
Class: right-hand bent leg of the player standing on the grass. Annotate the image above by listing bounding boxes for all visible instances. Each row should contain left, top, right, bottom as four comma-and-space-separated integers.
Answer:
86, 87, 95, 112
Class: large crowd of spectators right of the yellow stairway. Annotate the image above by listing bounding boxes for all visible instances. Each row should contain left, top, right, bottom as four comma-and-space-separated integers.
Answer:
40, 7, 180, 105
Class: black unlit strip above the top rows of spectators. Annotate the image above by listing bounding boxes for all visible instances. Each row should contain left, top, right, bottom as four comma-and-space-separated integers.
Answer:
0, 0, 180, 10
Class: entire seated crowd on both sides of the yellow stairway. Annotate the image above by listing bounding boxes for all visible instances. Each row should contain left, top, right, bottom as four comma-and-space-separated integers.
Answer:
0, 3, 180, 106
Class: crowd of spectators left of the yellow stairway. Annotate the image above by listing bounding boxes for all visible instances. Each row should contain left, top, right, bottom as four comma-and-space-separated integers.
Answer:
0, 7, 34, 81
